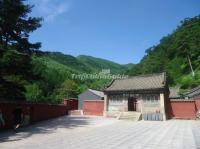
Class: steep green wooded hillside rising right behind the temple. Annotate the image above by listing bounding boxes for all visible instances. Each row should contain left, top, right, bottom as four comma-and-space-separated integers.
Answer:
128, 16, 200, 89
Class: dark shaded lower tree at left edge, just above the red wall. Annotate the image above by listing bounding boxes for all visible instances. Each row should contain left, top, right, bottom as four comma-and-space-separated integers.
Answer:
0, 48, 32, 100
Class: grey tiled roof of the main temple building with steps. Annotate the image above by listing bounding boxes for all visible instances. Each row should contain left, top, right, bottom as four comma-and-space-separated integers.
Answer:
105, 73, 166, 91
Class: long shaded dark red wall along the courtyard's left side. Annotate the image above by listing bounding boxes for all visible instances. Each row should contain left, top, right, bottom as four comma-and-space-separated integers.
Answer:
0, 102, 67, 128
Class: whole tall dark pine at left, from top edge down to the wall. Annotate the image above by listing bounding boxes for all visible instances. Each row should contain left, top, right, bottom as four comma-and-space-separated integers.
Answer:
0, 0, 42, 100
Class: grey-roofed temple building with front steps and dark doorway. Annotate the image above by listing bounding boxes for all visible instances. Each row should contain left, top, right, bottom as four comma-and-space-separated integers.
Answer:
104, 73, 169, 120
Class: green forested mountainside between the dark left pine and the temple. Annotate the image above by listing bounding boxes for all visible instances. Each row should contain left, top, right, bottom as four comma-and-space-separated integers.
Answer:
28, 52, 133, 102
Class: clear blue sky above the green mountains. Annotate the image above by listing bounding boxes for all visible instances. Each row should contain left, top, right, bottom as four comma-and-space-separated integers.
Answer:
28, 0, 200, 64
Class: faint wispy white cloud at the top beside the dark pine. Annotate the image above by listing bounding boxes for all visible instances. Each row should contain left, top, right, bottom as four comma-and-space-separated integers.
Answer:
32, 0, 70, 22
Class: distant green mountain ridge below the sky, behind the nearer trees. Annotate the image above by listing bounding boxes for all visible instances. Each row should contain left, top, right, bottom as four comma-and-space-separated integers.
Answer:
40, 52, 134, 74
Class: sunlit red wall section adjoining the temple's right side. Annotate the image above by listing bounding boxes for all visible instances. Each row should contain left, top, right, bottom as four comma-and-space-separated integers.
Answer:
168, 101, 196, 119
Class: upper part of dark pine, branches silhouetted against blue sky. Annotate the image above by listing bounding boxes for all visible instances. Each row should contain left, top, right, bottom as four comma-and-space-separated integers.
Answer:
0, 0, 42, 53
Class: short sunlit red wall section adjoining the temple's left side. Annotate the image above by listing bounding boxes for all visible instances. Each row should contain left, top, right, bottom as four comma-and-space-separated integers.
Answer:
83, 100, 104, 116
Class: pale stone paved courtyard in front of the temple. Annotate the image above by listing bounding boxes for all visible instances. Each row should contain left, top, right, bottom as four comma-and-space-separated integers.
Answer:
0, 116, 200, 149
